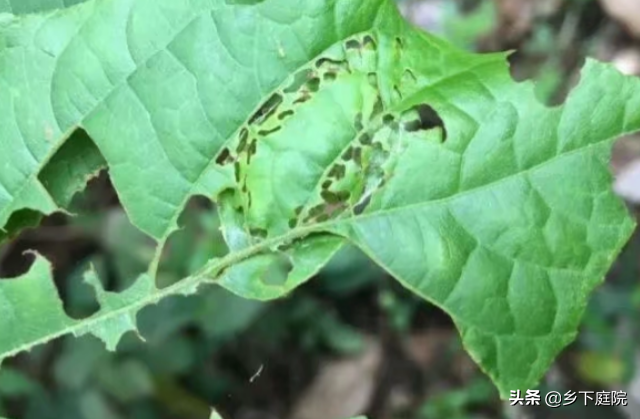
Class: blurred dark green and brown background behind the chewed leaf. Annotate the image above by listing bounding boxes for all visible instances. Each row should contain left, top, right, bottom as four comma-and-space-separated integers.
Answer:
0, 0, 640, 419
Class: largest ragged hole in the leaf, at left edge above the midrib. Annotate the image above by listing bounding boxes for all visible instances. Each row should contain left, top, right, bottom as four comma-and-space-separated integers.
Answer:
0, 166, 156, 319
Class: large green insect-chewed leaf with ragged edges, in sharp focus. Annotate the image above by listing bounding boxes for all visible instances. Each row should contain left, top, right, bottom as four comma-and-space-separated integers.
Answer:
0, 0, 640, 402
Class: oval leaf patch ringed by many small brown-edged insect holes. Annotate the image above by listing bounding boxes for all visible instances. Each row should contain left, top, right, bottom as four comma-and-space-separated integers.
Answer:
216, 34, 446, 239
